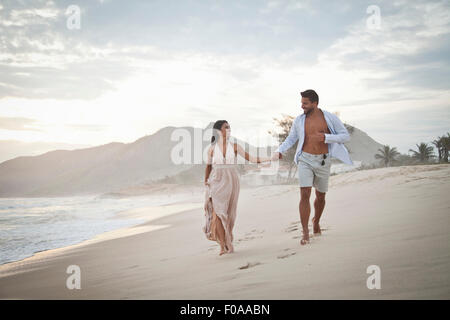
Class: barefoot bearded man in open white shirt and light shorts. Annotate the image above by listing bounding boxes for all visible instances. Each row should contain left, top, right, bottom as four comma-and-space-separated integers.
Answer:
274, 90, 353, 245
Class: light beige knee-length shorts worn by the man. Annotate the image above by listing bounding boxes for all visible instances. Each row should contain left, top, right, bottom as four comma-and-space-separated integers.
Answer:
298, 151, 331, 192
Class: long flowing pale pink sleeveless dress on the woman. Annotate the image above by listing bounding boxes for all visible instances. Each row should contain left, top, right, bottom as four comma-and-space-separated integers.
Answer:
203, 141, 240, 250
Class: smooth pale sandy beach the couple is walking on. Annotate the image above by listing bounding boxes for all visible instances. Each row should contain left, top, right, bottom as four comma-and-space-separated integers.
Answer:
0, 165, 450, 299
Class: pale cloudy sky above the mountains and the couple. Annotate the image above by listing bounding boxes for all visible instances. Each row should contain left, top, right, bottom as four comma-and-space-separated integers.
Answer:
0, 0, 450, 153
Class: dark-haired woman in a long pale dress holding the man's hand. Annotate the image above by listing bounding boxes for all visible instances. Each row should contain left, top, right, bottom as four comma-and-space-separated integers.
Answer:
203, 120, 271, 255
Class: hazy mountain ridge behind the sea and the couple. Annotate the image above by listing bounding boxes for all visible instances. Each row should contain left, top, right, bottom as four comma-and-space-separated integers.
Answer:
0, 124, 382, 197
